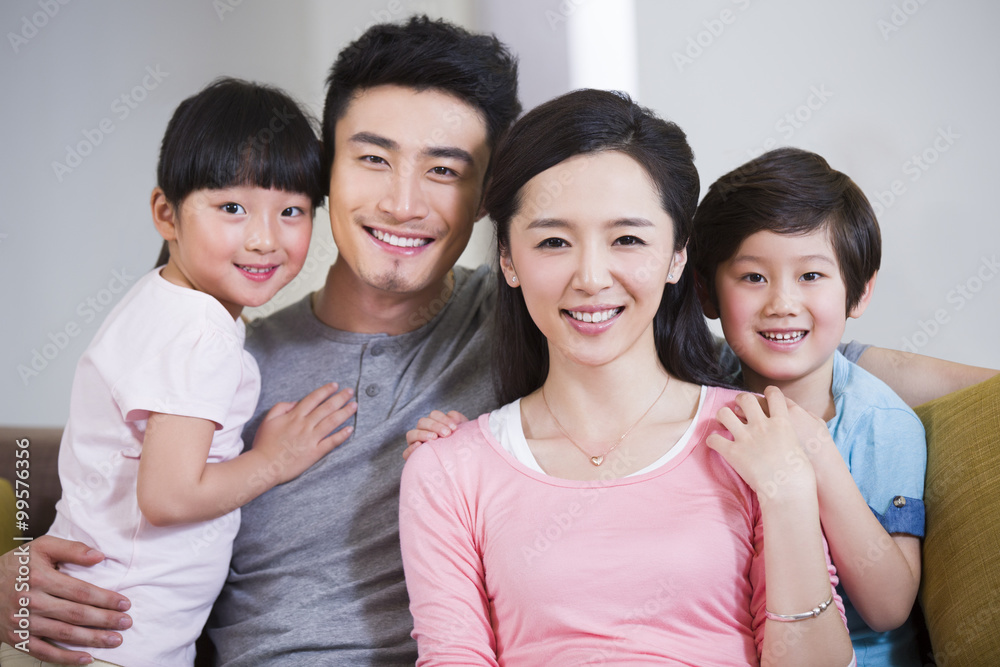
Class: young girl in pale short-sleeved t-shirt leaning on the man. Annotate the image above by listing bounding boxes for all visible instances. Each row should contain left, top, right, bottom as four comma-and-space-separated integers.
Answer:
2, 79, 356, 667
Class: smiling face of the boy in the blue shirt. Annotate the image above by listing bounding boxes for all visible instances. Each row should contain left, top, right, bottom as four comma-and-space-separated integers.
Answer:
715, 228, 871, 391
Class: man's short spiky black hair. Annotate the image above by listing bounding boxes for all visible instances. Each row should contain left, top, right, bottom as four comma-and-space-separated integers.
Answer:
323, 16, 521, 183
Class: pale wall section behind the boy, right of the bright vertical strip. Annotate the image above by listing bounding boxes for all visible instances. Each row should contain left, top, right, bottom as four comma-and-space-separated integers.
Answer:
636, 0, 1000, 368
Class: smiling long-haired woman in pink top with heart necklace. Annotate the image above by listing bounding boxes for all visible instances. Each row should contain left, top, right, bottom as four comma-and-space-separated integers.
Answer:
400, 90, 852, 665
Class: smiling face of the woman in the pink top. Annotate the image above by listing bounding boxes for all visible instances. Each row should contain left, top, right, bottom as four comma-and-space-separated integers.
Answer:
500, 151, 687, 366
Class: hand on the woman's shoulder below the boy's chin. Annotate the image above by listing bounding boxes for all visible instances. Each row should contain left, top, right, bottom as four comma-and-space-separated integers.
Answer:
705, 387, 816, 503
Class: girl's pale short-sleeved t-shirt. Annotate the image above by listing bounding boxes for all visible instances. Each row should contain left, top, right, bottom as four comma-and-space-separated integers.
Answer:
49, 271, 260, 667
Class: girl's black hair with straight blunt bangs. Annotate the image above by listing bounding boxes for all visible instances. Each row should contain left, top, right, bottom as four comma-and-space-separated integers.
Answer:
156, 77, 326, 266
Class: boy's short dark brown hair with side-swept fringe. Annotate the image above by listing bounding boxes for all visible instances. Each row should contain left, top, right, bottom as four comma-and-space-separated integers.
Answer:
689, 148, 882, 313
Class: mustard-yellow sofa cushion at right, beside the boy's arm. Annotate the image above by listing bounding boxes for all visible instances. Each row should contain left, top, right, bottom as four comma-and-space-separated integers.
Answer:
916, 376, 1000, 667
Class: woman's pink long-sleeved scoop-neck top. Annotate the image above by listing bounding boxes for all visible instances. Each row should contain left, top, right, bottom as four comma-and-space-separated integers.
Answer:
399, 388, 840, 666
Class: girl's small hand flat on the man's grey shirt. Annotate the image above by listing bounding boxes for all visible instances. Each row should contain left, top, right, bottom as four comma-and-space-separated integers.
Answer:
253, 382, 358, 484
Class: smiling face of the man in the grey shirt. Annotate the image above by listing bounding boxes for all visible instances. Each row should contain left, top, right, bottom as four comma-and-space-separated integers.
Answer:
330, 85, 490, 293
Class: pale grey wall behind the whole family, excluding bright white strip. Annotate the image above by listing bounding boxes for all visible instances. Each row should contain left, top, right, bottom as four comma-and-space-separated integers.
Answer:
0, 0, 1000, 425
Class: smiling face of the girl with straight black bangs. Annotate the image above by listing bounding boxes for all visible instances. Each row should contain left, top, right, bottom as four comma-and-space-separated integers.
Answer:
152, 186, 312, 318
